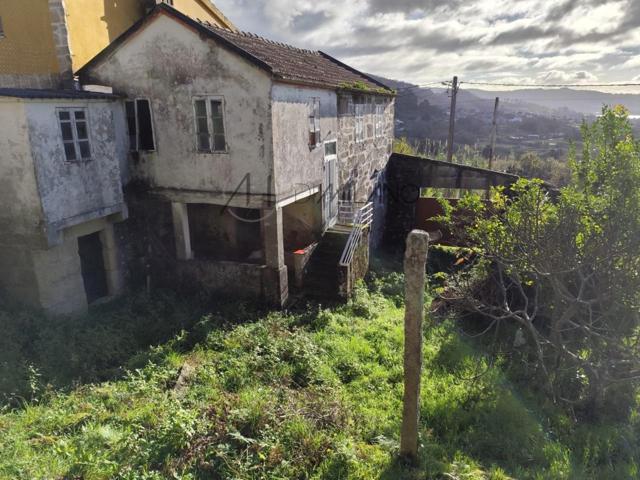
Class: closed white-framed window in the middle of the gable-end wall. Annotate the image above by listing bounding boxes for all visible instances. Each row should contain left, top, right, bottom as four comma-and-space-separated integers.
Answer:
193, 97, 227, 153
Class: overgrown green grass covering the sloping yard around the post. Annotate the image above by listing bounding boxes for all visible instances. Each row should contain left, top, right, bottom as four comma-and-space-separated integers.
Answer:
0, 280, 640, 480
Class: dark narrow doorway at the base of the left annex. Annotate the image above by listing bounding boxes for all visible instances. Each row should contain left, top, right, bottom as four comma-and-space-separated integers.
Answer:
78, 232, 109, 304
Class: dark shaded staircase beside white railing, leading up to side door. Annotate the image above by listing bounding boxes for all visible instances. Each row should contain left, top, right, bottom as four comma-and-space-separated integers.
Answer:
303, 225, 351, 299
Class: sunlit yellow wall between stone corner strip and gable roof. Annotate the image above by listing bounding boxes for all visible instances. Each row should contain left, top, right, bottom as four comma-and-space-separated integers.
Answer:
65, 0, 144, 71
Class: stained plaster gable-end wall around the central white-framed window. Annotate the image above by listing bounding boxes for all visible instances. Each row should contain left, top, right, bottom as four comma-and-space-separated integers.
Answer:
88, 15, 273, 194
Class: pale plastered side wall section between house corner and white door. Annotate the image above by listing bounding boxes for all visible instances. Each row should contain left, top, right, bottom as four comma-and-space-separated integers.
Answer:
271, 84, 340, 198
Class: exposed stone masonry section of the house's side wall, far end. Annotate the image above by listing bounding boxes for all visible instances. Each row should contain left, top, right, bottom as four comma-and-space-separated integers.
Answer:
338, 94, 395, 202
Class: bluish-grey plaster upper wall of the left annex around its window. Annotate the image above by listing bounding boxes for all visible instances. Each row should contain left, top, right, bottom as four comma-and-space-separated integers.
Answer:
25, 100, 126, 239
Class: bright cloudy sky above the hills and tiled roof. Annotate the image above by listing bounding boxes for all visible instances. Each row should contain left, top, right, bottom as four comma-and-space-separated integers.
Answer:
214, 0, 640, 89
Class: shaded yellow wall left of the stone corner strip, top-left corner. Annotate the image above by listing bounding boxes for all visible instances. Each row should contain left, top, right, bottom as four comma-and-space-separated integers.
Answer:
0, 0, 59, 75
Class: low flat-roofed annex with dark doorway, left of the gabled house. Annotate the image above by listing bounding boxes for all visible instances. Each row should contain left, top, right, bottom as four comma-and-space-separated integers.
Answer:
0, 89, 127, 314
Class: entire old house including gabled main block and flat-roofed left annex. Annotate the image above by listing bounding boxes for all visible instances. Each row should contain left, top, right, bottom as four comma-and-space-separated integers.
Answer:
0, 4, 394, 313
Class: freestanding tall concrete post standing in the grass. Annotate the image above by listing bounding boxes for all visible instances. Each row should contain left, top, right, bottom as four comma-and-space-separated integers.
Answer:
400, 230, 429, 461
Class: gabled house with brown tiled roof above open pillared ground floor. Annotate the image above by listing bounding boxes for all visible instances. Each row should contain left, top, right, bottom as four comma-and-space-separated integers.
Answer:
80, 8, 393, 304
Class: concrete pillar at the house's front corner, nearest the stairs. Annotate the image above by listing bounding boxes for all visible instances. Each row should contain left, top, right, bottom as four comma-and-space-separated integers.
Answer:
262, 208, 289, 306
